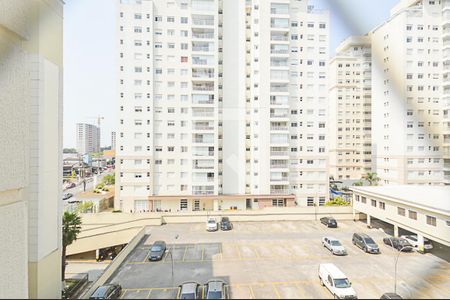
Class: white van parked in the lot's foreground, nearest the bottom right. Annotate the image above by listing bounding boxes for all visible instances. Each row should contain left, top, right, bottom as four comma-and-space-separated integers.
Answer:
319, 264, 358, 299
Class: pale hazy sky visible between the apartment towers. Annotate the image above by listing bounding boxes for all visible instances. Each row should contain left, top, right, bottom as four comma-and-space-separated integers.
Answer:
64, 0, 400, 148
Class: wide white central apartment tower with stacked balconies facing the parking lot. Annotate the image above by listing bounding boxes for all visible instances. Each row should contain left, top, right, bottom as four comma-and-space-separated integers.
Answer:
115, 0, 329, 212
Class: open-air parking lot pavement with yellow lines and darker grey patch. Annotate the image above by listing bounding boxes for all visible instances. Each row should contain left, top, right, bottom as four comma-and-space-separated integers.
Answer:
110, 221, 450, 299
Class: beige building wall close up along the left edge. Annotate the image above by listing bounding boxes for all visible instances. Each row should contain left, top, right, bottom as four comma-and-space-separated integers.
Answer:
0, 0, 63, 299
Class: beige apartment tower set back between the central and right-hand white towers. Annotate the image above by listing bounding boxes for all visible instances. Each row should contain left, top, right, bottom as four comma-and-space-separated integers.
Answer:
329, 35, 372, 180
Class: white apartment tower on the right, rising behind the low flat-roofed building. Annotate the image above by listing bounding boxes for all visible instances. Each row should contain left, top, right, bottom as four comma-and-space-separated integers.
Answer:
372, 0, 448, 185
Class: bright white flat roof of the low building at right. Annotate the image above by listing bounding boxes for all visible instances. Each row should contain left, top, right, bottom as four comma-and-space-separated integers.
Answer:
350, 185, 450, 215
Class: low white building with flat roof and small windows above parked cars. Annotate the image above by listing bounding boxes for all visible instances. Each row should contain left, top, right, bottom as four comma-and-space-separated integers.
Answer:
351, 185, 450, 251
